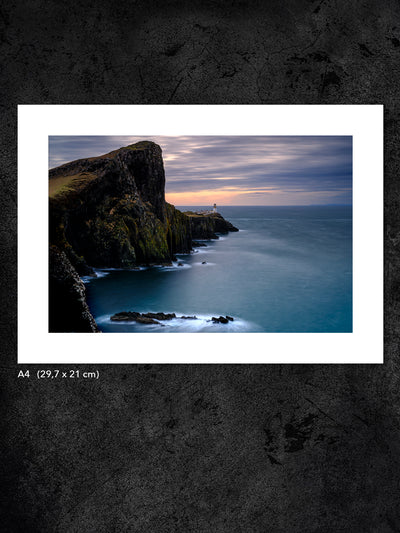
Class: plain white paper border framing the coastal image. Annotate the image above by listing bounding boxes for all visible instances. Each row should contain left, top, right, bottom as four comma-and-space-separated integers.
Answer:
18, 105, 383, 364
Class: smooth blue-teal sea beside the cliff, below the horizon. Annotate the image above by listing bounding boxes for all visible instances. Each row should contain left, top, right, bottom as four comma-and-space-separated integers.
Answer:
83, 205, 352, 333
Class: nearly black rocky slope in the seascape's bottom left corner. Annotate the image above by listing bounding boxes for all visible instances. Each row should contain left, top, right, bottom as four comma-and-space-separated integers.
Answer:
49, 246, 99, 333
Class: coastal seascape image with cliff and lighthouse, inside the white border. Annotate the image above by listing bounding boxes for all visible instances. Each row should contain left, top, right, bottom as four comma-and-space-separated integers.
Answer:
49, 135, 353, 333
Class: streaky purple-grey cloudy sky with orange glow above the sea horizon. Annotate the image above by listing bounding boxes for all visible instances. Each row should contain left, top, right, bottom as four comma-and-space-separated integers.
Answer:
49, 136, 352, 206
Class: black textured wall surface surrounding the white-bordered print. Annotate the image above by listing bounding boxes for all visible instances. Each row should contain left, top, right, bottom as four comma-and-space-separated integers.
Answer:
0, 0, 400, 533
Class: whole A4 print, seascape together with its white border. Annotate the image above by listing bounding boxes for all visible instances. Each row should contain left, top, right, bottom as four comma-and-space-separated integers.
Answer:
18, 105, 383, 363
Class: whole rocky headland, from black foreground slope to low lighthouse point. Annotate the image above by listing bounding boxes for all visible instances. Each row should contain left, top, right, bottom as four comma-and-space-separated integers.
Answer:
49, 141, 238, 332
